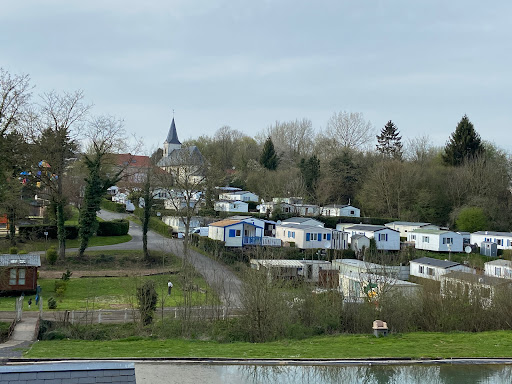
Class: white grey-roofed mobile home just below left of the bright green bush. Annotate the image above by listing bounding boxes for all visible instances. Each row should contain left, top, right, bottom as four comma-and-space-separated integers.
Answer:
407, 228, 464, 252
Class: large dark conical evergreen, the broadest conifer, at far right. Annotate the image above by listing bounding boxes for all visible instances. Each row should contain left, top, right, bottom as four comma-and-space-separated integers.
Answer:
443, 115, 484, 166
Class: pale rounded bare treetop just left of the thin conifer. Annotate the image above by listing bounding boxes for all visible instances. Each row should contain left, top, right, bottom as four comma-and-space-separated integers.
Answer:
326, 111, 375, 150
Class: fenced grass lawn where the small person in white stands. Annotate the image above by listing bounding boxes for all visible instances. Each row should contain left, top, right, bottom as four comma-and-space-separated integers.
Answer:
0, 274, 216, 311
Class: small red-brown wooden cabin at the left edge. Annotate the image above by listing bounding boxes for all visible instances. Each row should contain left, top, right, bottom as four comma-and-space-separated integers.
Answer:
0, 254, 41, 292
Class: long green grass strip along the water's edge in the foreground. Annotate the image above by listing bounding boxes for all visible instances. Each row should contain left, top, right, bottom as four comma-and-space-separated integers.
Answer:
25, 331, 512, 359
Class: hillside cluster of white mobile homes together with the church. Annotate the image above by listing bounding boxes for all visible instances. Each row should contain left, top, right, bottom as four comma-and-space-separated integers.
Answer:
98, 119, 512, 305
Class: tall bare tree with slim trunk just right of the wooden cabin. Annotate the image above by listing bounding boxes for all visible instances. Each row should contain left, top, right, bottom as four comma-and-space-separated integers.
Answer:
34, 91, 90, 258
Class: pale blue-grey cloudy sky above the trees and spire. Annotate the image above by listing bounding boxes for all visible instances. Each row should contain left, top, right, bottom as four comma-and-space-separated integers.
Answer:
0, 0, 512, 152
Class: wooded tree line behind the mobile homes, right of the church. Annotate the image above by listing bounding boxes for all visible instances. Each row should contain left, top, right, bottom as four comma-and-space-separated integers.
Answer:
189, 112, 512, 231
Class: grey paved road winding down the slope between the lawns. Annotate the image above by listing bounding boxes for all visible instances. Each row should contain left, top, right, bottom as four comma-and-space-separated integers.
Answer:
91, 210, 242, 307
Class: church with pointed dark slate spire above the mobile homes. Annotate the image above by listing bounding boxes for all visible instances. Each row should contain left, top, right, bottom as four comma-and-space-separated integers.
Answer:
157, 117, 205, 184
